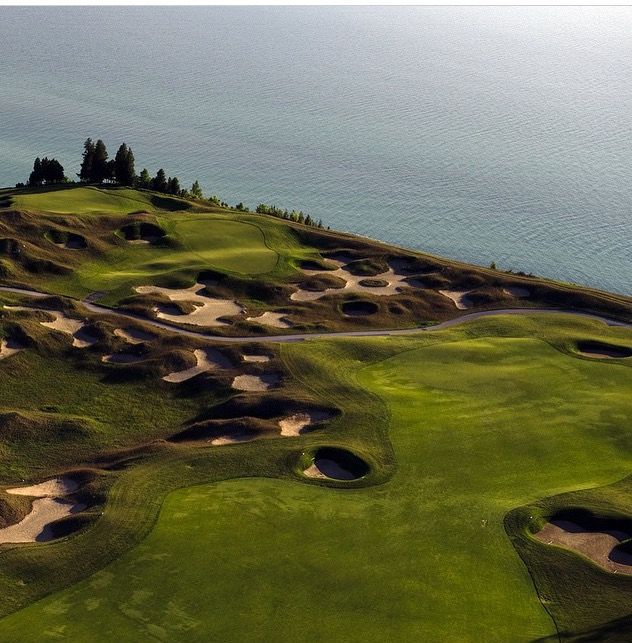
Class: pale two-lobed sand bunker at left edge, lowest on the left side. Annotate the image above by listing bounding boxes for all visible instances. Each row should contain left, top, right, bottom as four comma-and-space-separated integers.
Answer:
0, 478, 85, 543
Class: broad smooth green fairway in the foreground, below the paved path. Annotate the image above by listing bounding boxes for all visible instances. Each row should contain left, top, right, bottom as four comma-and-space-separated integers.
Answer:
0, 316, 632, 642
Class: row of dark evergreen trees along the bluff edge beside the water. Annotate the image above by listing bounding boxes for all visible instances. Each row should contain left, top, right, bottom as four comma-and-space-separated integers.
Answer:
16, 138, 323, 228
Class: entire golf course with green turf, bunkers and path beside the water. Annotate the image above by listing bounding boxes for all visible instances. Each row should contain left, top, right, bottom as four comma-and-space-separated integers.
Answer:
0, 184, 632, 643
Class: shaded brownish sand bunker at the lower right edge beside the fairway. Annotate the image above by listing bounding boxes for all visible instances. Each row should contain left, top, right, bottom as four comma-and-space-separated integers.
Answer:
535, 520, 632, 574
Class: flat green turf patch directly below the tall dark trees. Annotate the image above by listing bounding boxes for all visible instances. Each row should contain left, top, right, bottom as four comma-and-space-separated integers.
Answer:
11, 187, 190, 214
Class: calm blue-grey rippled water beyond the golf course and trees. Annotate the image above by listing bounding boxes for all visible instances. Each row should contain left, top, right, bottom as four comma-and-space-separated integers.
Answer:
0, 7, 632, 294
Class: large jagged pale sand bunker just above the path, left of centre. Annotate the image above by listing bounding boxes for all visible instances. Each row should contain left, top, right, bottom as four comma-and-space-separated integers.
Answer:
135, 283, 244, 326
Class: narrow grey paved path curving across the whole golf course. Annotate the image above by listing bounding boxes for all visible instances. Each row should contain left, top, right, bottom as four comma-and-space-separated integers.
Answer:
0, 286, 632, 344
